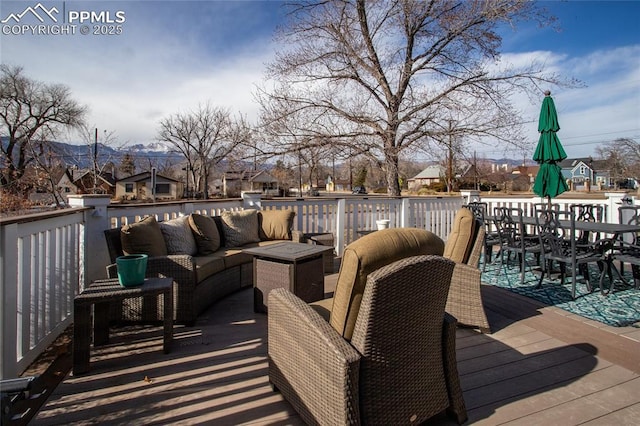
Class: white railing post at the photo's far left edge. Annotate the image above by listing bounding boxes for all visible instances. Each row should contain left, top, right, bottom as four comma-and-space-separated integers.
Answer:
0, 223, 18, 379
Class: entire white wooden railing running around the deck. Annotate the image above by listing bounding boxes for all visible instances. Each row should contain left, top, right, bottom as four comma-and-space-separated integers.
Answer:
0, 194, 625, 378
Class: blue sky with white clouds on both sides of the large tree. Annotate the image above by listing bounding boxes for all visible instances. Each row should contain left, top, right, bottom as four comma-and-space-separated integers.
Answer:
0, 0, 640, 158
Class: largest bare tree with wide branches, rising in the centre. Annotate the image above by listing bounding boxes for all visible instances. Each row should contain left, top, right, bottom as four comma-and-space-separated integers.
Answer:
259, 0, 575, 195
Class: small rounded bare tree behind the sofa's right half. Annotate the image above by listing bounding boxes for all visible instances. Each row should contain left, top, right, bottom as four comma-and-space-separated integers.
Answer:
158, 104, 251, 198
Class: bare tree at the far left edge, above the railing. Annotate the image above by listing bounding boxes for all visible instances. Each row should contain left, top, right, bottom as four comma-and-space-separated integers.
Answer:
0, 65, 86, 194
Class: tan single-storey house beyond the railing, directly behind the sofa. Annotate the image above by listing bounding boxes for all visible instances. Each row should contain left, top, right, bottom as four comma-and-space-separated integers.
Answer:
115, 172, 183, 201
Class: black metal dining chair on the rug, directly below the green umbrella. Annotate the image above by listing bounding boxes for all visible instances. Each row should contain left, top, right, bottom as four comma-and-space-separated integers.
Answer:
536, 206, 613, 299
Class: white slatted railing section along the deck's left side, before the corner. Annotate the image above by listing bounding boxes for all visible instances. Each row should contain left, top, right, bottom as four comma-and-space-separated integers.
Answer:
0, 210, 84, 378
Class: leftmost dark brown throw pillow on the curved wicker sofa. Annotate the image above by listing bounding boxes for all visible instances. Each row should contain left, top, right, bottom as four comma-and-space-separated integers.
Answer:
120, 216, 167, 256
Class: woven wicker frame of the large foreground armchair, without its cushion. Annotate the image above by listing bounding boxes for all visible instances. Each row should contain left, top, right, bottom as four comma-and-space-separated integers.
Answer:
268, 255, 467, 425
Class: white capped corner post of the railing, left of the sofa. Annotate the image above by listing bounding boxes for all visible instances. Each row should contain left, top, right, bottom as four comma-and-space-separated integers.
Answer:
69, 194, 111, 288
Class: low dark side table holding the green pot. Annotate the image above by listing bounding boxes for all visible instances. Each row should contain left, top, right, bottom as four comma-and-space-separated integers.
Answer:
73, 278, 173, 374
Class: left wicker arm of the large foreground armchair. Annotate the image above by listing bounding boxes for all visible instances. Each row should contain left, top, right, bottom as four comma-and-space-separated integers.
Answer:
268, 288, 361, 424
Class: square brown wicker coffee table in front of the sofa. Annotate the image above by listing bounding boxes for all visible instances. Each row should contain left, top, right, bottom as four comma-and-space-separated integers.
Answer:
244, 242, 333, 313
